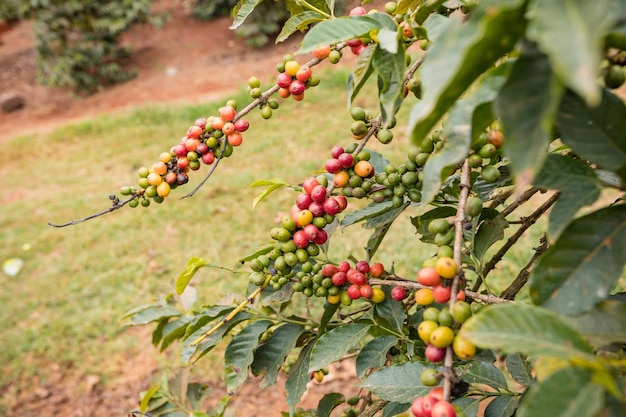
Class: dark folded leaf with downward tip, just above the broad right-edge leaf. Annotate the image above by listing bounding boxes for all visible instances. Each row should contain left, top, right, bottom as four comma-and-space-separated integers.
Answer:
534, 154, 600, 242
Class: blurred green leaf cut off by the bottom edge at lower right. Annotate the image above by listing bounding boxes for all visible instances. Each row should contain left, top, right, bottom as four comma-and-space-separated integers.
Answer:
515, 367, 604, 417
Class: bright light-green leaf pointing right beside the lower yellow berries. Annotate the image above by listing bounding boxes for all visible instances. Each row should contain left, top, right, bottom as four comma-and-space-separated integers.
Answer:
459, 303, 595, 360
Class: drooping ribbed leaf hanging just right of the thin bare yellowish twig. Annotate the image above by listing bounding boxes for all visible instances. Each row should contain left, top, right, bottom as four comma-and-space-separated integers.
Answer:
224, 320, 272, 392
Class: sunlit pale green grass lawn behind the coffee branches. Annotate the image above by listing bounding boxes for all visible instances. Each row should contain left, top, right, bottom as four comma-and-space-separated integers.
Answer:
0, 66, 544, 404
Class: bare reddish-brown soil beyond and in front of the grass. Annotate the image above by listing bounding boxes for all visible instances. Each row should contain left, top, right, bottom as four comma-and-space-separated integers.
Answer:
0, 0, 356, 417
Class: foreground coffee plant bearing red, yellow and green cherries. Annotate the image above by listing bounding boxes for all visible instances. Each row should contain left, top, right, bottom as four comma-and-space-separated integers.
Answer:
57, 0, 626, 417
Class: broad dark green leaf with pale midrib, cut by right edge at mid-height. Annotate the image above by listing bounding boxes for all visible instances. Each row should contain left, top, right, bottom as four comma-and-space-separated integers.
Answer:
529, 205, 626, 315
